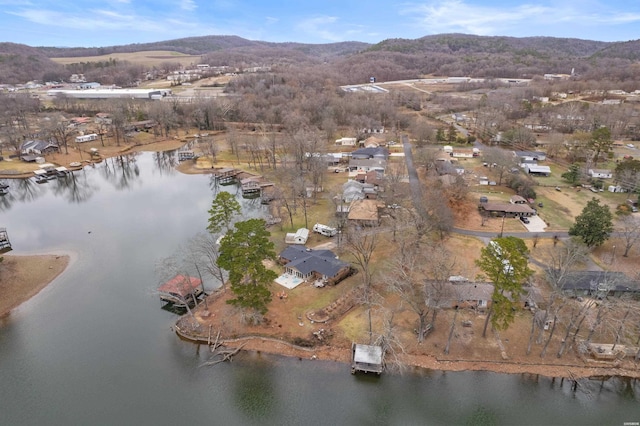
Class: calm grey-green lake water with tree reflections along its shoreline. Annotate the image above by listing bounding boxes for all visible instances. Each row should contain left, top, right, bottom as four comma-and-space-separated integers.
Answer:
0, 153, 640, 425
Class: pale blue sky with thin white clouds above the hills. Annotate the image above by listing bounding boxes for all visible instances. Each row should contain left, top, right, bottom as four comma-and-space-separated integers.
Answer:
0, 0, 640, 47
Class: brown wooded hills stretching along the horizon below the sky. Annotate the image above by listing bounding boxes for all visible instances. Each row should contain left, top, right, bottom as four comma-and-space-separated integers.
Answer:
0, 34, 640, 84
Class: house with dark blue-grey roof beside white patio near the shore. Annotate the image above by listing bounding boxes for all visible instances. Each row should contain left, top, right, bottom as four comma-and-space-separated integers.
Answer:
278, 245, 351, 285
